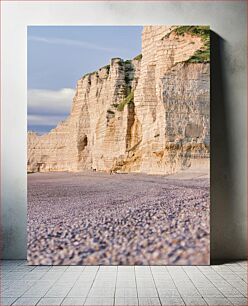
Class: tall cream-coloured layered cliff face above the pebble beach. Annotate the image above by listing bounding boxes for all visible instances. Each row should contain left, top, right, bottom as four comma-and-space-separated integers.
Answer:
28, 26, 210, 174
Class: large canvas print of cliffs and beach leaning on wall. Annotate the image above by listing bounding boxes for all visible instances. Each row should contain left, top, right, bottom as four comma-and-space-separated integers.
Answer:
27, 25, 210, 265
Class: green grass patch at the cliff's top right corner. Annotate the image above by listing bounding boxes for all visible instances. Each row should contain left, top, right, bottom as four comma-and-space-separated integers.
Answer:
165, 26, 210, 63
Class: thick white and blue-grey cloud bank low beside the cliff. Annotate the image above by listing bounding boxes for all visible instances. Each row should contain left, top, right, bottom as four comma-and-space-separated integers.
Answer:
28, 88, 75, 129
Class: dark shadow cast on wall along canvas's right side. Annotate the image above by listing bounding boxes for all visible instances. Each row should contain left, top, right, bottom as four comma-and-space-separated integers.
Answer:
210, 32, 244, 263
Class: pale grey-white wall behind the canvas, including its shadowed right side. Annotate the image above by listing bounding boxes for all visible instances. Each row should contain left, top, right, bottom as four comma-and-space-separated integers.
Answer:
1, 1, 247, 259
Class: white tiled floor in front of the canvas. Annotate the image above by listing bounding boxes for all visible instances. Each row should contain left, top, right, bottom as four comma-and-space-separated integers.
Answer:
0, 261, 248, 306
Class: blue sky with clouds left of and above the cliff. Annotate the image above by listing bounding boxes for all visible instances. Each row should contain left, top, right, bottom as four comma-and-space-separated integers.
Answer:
27, 26, 142, 134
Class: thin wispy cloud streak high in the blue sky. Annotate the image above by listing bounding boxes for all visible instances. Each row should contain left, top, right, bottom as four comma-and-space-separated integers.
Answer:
28, 36, 116, 52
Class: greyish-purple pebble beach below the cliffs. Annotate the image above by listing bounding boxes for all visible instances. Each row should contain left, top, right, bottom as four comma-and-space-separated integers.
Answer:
27, 172, 210, 265
